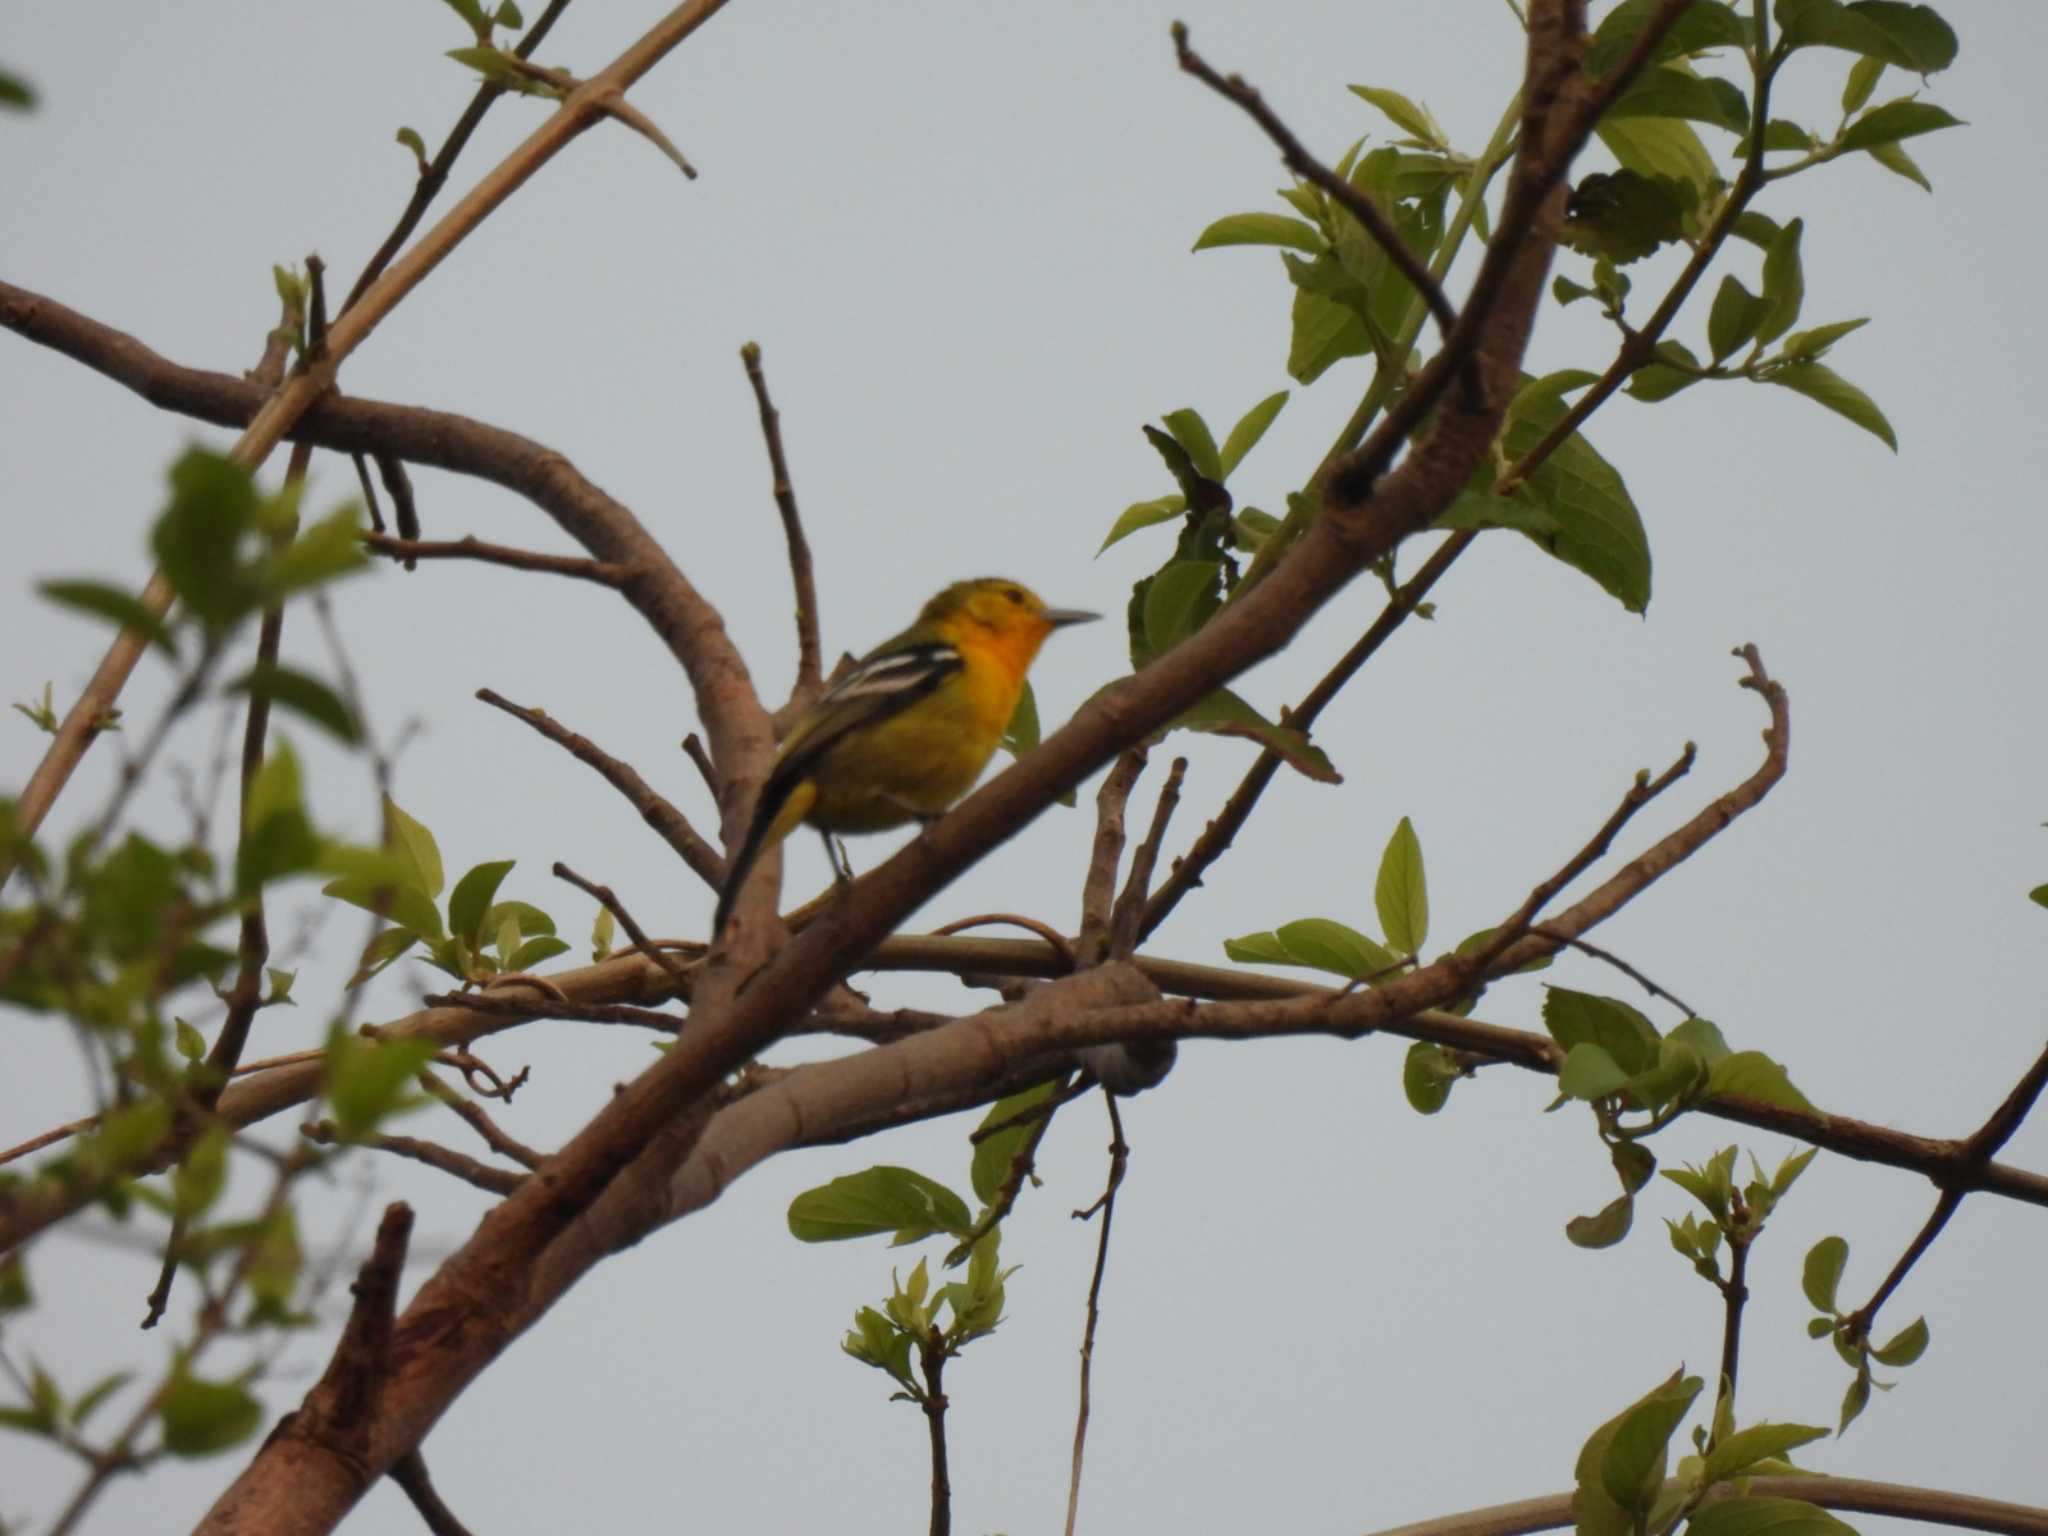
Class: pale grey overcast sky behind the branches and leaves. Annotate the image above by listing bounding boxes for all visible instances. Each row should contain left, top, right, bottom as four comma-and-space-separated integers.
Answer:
0, 0, 2048, 1536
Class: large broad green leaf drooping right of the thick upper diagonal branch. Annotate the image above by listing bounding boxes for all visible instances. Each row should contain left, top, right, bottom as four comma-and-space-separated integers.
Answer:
1501, 381, 1651, 612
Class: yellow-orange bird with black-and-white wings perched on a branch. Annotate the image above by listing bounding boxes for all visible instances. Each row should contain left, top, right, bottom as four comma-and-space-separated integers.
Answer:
711, 575, 1102, 938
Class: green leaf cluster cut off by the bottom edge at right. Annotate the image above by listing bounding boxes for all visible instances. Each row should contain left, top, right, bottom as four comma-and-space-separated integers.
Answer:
1573, 1370, 1851, 1536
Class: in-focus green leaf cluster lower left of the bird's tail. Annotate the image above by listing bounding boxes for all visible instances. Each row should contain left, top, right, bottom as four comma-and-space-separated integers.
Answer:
322, 795, 569, 987
